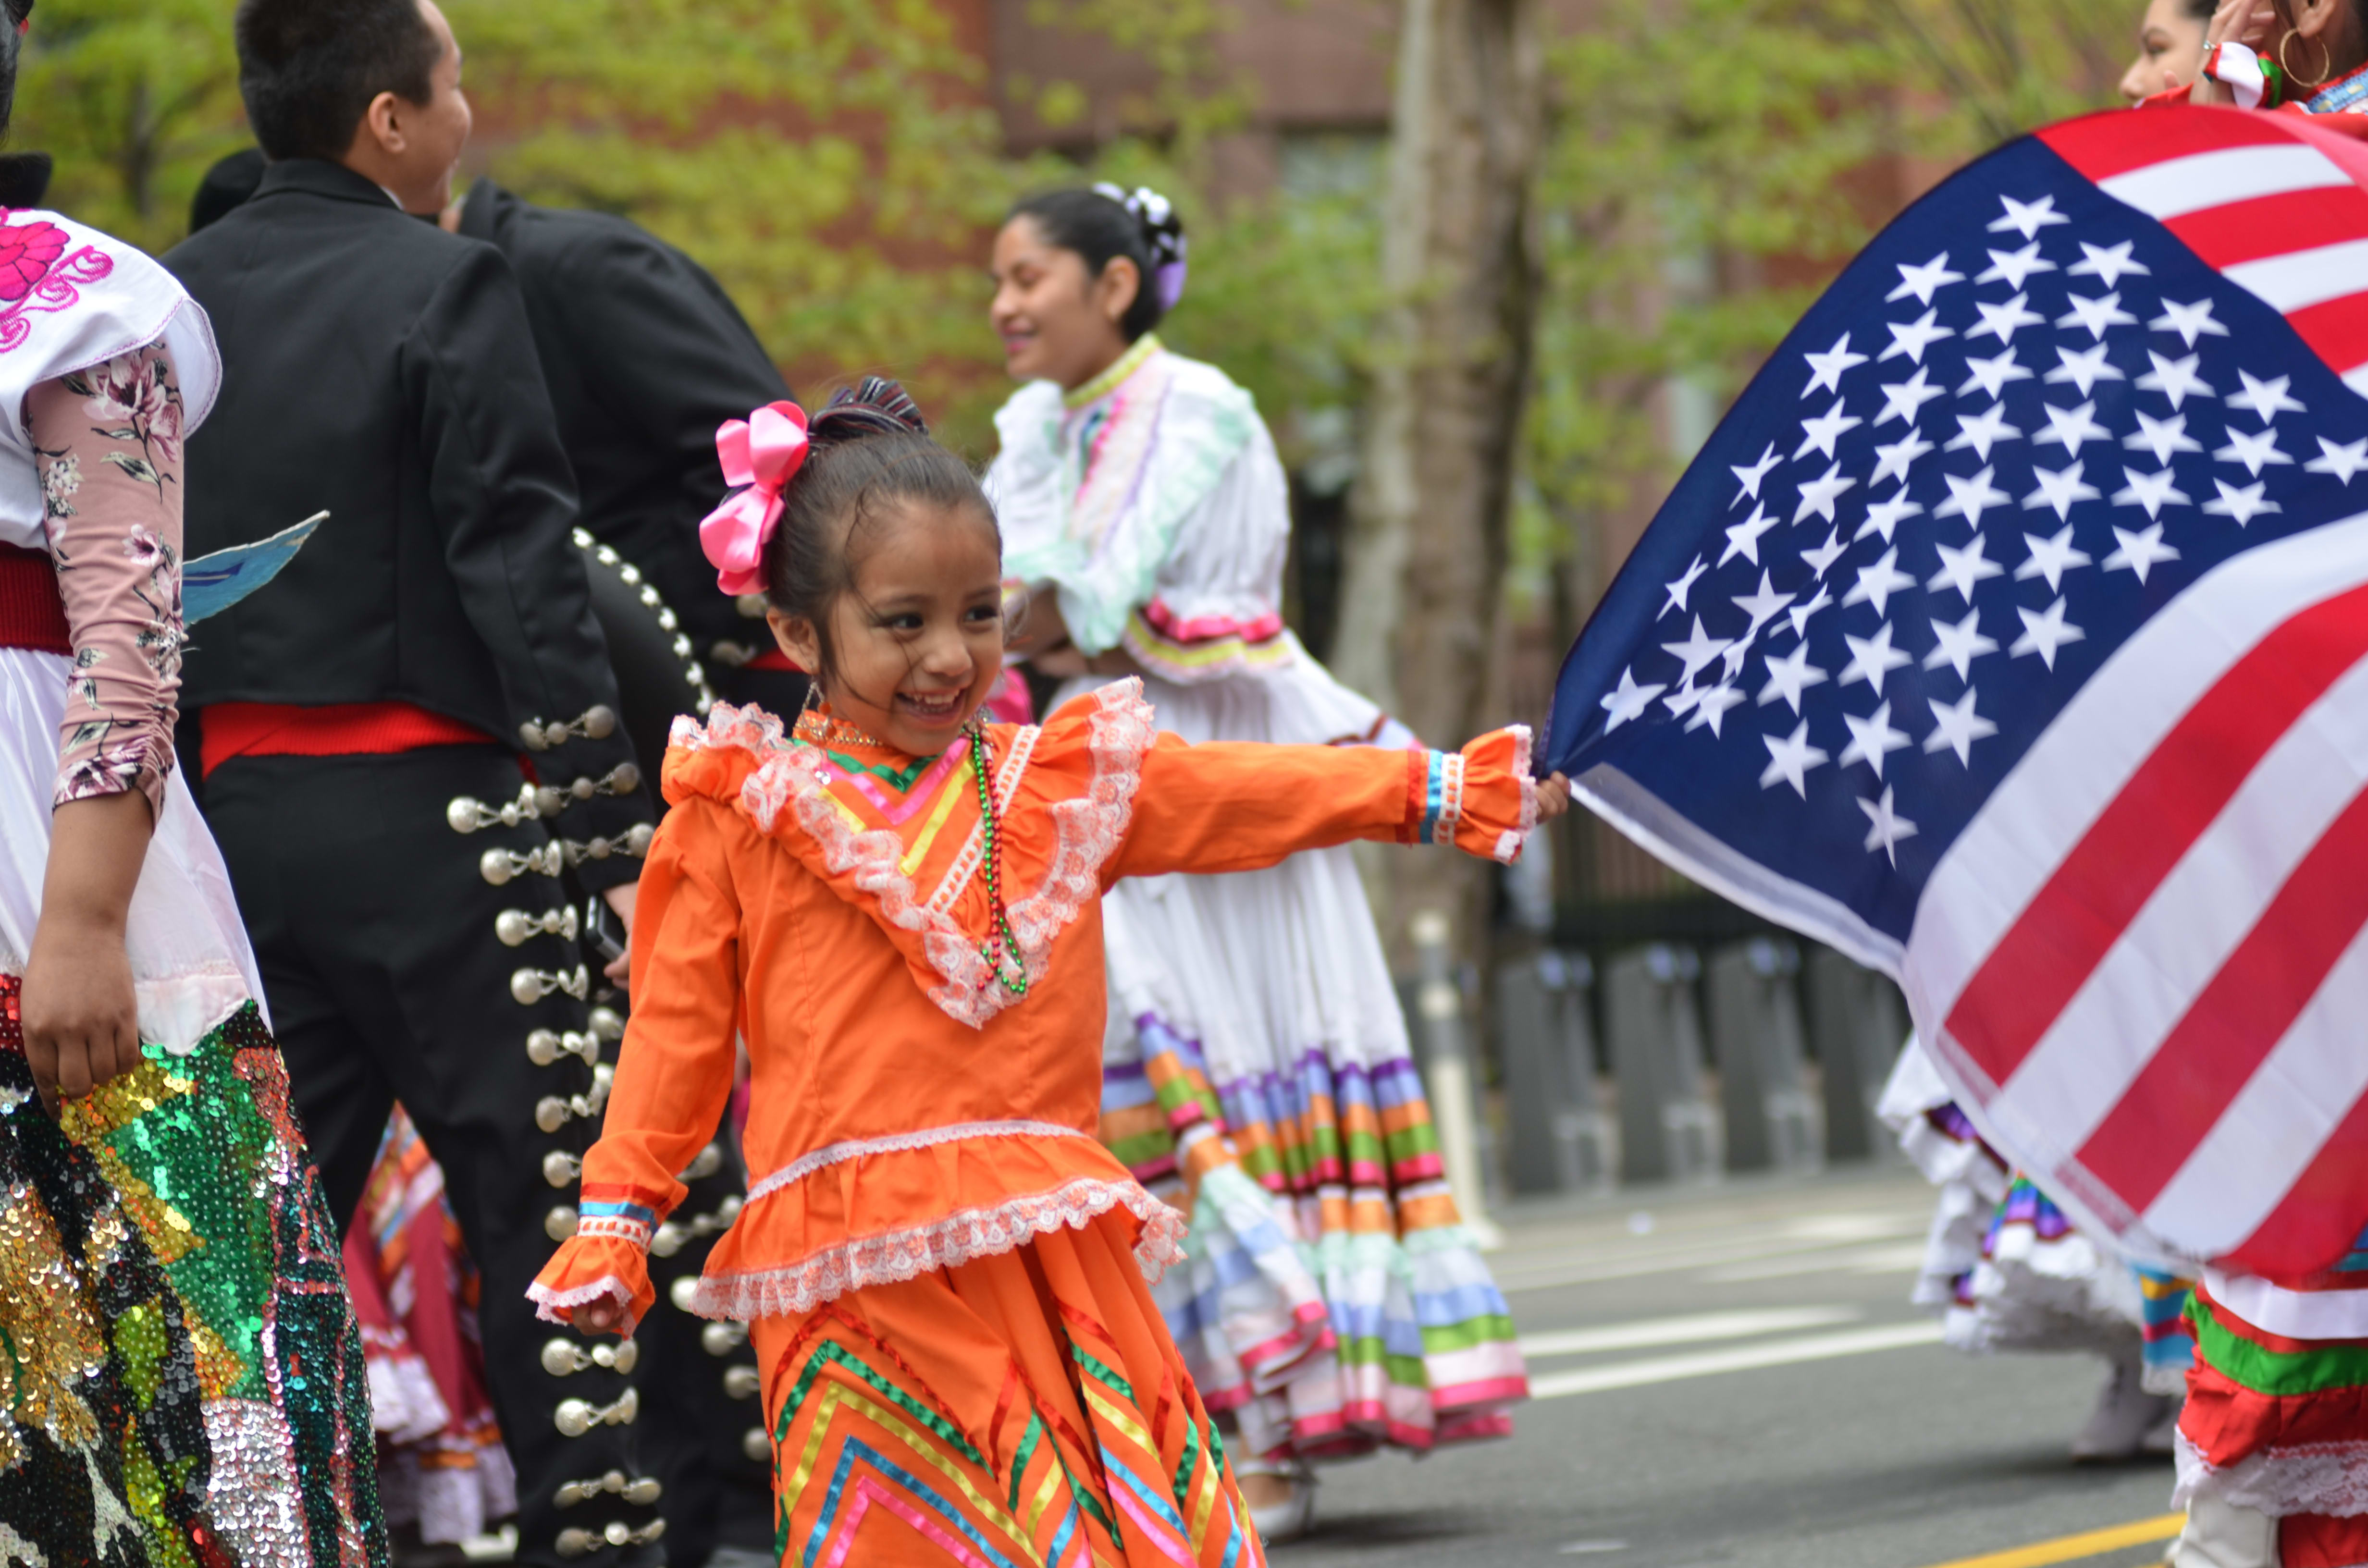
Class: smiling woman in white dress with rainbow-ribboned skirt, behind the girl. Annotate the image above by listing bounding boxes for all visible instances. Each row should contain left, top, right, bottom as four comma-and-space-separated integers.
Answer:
987, 187, 1528, 1535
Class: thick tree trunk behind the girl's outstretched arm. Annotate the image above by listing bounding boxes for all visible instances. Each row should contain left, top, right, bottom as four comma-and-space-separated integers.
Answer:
1333, 0, 1544, 952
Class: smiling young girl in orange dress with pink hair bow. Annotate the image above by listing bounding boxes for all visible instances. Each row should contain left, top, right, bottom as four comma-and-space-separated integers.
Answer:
533, 381, 1567, 1568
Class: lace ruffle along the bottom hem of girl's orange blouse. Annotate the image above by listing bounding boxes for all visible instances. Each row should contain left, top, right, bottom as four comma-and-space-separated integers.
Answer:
691, 1177, 1186, 1322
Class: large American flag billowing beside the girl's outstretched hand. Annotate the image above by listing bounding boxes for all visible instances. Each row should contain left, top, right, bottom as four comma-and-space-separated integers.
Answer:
1546, 109, 2368, 1274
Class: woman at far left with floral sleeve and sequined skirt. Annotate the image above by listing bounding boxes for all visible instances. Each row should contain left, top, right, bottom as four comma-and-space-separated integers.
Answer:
0, 0, 388, 1568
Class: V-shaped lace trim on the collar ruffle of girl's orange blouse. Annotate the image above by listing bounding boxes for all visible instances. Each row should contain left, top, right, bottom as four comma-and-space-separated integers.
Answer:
673, 677, 1158, 1028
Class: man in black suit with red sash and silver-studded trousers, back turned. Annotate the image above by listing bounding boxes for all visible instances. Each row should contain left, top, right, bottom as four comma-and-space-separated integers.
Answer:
166, 0, 663, 1568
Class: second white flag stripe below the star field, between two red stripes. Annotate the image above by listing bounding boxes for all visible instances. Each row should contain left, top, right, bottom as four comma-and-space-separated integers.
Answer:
1989, 661, 2368, 1191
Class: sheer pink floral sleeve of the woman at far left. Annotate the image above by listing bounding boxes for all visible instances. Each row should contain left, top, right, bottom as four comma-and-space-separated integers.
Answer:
26, 343, 182, 810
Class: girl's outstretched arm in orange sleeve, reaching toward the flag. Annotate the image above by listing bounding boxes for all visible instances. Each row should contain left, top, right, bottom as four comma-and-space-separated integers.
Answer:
1103, 725, 1570, 881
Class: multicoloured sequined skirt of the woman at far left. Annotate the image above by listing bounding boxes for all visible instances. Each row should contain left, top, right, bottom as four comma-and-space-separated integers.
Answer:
0, 976, 386, 1568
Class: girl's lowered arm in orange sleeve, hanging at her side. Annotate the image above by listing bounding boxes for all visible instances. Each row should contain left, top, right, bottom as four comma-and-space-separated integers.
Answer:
528, 798, 741, 1334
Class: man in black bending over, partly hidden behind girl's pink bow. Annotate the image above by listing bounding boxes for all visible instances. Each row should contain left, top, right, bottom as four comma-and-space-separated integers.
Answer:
443, 180, 786, 1568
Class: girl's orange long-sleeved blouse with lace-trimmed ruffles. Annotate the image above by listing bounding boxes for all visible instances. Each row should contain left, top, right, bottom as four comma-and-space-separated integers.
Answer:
530, 680, 1537, 1322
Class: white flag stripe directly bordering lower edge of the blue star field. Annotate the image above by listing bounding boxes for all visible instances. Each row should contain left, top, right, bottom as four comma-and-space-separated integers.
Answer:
1901, 509, 2368, 1028
